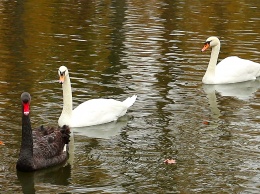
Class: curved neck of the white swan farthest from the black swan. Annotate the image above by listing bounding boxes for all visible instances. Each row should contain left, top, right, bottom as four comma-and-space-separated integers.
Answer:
202, 44, 220, 84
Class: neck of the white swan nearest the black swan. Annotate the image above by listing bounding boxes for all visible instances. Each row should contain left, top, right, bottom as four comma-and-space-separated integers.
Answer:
59, 75, 72, 126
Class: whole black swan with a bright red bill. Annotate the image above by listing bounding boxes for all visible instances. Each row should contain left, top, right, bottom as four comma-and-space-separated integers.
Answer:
16, 92, 70, 171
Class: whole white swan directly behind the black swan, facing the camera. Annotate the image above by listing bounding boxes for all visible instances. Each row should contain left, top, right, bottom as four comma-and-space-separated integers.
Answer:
58, 66, 137, 127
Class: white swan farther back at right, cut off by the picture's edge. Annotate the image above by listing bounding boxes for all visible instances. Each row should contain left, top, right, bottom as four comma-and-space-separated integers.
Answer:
201, 36, 260, 84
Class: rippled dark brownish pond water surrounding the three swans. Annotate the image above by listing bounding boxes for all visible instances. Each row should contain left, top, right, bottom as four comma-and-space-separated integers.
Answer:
0, 0, 260, 193
